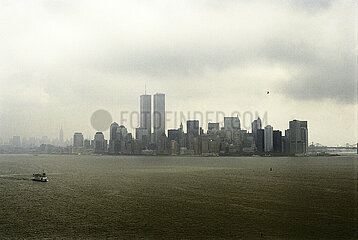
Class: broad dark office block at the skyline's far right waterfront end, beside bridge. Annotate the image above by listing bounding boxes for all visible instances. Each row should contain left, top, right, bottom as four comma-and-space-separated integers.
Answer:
288, 120, 308, 154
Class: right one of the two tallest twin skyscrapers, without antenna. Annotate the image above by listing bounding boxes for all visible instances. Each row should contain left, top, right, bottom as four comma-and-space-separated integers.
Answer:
153, 93, 165, 143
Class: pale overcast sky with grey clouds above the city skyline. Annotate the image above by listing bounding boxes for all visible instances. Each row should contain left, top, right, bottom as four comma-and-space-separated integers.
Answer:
0, 0, 358, 145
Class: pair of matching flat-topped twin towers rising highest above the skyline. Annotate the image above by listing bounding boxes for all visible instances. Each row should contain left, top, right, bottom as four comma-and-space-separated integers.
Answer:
136, 93, 165, 143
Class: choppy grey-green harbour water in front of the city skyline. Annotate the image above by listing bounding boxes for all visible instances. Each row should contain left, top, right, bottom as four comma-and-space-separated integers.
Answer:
0, 155, 358, 239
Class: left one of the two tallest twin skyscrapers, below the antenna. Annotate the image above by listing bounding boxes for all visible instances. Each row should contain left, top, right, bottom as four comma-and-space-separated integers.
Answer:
140, 94, 152, 136
